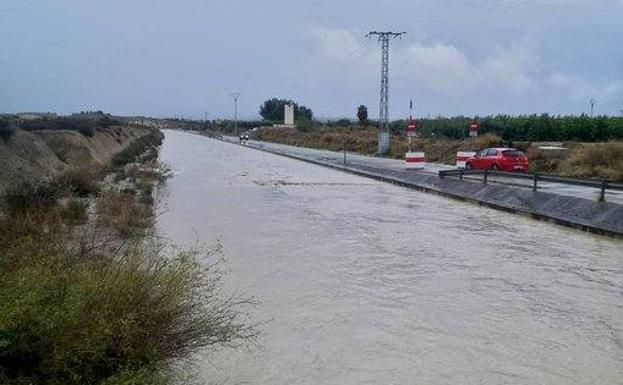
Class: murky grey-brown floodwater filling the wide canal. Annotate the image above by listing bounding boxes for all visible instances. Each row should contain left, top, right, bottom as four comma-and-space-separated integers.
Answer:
158, 131, 623, 384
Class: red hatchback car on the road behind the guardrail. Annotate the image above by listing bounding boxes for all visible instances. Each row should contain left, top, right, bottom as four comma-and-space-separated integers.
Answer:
465, 148, 528, 172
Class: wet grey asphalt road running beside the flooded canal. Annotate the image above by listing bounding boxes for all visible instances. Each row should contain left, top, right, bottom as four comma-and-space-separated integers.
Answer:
224, 137, 623, 204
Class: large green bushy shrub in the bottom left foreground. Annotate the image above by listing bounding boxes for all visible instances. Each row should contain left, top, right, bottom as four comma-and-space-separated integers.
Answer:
0, 245, 253, 385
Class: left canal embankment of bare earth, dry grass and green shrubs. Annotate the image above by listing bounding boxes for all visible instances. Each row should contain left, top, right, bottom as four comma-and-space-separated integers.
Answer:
0, 127, 255, 385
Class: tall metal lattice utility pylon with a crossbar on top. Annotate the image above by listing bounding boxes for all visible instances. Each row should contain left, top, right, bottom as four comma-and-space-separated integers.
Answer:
366, 31, 406, 155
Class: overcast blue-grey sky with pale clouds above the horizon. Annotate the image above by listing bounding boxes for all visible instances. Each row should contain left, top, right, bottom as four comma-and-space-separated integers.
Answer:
0, 0, 623, 119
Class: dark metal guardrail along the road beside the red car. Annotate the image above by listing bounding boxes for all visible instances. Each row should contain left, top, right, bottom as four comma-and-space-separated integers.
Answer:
439, 169, 623, 202
